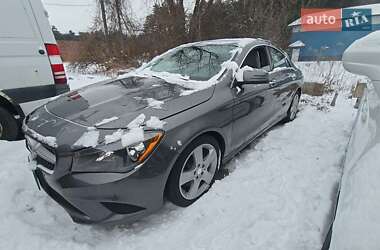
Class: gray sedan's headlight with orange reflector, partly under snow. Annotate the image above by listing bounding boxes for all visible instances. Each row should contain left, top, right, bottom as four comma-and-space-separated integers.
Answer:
72, 131, 164, 173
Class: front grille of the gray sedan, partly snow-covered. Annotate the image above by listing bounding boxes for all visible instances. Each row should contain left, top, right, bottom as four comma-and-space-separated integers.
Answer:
25, 136, 57, 172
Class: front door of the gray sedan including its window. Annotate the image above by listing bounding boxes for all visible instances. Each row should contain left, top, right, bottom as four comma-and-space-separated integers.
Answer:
232, 46, 275, 149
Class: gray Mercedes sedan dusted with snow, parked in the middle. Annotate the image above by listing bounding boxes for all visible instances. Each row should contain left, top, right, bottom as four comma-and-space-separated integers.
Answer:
23, 38, 303, 224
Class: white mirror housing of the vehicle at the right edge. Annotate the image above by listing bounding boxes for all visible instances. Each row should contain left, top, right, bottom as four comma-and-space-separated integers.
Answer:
342, 31, 380, 81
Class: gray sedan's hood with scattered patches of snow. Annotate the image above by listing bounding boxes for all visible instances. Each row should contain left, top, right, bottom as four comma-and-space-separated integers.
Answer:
45, 77, 214, 129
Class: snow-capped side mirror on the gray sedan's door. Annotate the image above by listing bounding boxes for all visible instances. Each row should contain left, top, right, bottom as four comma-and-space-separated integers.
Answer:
236, 66, 269, 84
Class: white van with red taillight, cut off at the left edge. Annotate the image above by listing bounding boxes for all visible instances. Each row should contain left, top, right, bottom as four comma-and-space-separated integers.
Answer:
0, 0, 69, 140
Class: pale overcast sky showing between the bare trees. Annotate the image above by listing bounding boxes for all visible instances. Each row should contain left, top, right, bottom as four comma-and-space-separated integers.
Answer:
42, 0, 192, 32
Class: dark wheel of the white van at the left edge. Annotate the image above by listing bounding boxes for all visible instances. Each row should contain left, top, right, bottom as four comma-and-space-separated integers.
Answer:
0, 107, 19, 141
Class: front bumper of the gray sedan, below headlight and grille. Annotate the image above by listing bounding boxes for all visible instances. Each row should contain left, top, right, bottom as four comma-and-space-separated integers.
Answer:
28, 140, 170, 224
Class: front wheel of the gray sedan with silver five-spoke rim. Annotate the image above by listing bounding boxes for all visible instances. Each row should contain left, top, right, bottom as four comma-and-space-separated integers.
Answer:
166, 136, 221, 207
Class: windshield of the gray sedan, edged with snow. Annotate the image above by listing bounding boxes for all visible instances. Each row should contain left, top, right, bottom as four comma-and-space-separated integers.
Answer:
146, 44, 237, 81
